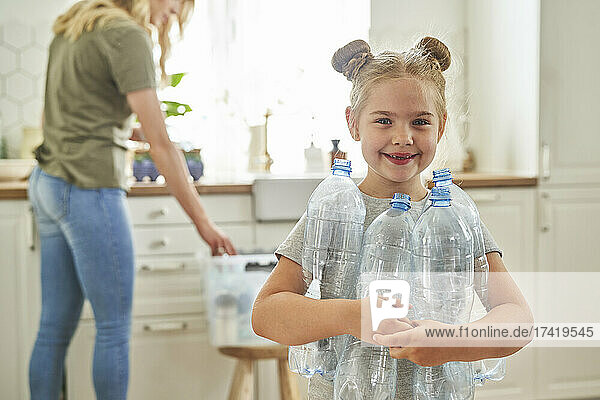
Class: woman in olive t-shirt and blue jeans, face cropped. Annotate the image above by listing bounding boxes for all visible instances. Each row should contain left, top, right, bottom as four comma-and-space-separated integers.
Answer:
29, 0, 235, 400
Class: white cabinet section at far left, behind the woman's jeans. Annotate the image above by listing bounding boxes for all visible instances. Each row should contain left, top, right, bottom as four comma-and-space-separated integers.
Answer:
0, 200, 40, 400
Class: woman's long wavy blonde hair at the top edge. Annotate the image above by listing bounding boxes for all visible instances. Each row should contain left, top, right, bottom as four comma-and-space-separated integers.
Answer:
52, 0, 194, 81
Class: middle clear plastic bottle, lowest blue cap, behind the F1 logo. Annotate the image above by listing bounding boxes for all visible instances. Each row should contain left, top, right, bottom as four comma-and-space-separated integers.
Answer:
334, 193, 414, 400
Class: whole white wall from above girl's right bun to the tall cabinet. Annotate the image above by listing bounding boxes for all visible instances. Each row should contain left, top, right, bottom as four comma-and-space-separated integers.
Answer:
370, 0, 539, 175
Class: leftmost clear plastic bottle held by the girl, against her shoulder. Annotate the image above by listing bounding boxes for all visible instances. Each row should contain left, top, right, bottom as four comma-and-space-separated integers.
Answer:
289, 159, 366, 380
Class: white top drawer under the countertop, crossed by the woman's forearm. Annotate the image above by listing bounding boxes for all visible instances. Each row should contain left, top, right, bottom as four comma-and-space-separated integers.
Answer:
128, 194, 252, 225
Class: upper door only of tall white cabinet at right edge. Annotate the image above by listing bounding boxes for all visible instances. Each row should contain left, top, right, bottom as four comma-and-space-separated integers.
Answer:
539, 0, 600, 184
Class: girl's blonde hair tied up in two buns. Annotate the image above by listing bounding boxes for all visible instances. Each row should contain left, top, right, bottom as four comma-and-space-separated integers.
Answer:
331, 36, 450, 126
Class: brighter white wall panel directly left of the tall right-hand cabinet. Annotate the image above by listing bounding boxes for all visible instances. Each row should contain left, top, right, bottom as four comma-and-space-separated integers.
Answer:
466, 0, 540, 175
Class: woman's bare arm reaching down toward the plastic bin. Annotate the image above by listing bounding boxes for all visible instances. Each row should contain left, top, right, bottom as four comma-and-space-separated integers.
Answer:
127, 88, 236, 255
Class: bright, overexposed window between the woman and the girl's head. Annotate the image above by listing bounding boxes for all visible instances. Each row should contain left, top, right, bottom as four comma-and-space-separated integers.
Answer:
159, 0, 370, 180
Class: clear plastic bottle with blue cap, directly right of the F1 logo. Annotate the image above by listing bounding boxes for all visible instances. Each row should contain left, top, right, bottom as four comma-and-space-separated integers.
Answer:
412, 187, 474, 400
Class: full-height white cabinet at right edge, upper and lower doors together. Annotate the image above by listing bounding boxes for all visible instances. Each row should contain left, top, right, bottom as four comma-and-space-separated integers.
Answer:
536, 0, 600, 399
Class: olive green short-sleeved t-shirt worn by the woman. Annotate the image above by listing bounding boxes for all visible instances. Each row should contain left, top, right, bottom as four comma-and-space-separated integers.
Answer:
35, 19, 156, 190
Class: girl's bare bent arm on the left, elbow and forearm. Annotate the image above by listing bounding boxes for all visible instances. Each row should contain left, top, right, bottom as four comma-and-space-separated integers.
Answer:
252, 256, 360, 346
